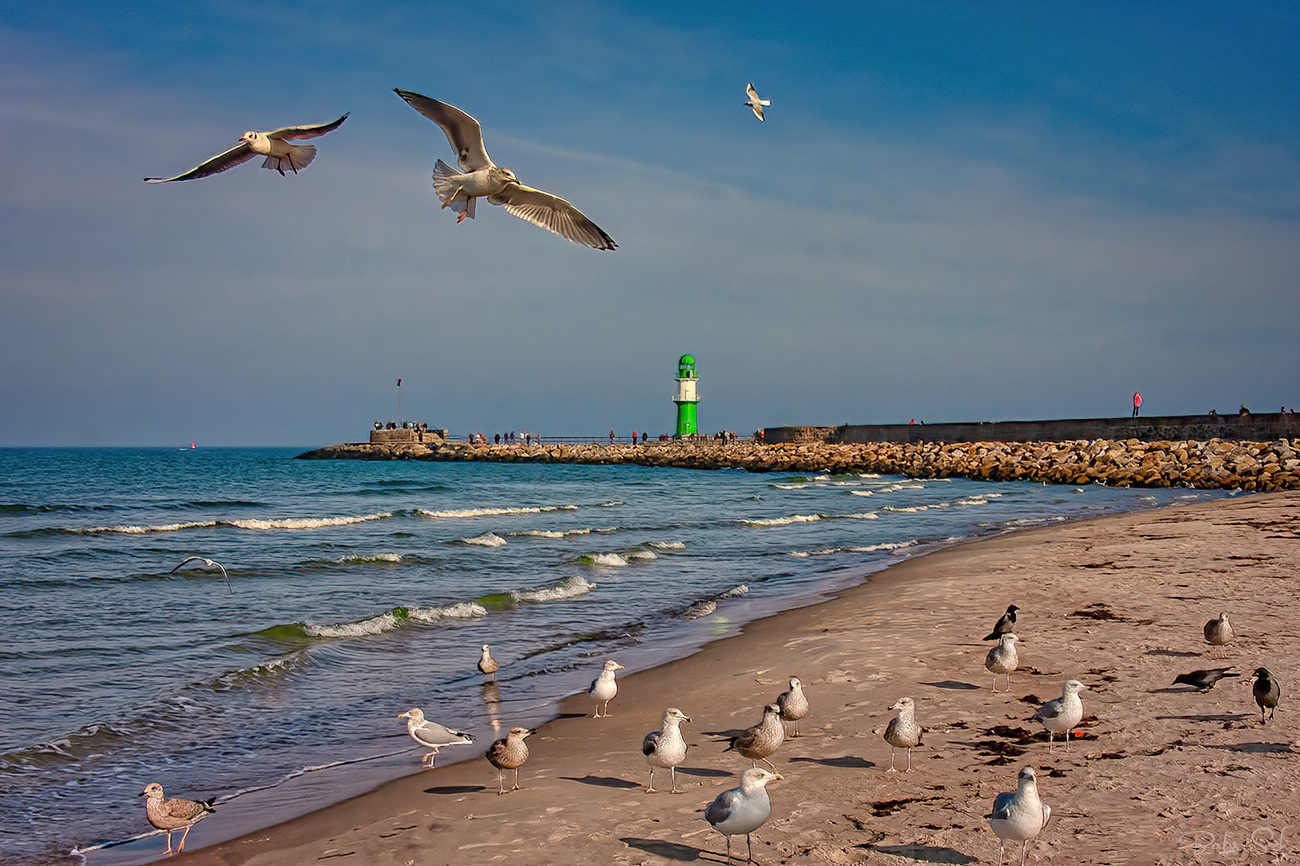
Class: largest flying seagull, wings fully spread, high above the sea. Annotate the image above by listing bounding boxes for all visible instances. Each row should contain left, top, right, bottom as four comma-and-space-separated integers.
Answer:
393, 87, 619, 250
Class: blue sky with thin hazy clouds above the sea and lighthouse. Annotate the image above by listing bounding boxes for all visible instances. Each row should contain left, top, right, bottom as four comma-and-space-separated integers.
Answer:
0, 0, 1300, 445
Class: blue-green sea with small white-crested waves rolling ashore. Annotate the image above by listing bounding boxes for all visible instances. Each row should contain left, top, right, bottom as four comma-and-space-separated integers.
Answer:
0, 447, 1229, 866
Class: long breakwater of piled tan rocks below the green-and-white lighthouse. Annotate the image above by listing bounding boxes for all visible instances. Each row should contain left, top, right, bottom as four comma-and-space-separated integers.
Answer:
298, 440, 1300, 492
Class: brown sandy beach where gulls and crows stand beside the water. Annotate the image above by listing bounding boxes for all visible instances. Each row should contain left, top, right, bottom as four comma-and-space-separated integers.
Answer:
154, 492, 1300, 866
